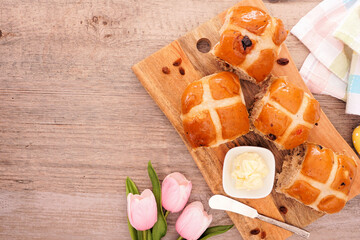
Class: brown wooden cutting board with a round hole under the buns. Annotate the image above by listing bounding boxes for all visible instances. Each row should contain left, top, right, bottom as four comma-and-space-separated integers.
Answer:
132, 0, 360, 240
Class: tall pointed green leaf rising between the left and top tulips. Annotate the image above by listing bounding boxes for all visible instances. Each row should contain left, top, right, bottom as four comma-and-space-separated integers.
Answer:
148, 161, 167, 240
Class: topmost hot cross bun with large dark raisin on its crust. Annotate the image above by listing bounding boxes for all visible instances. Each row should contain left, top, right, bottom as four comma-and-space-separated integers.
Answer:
212, 6, 288, 83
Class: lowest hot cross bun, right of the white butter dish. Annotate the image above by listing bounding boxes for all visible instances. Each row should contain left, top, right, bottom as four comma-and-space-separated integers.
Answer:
276, 143, 357, 213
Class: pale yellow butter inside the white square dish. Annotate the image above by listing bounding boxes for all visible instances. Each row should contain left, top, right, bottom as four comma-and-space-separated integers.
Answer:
231, 152, 269, 190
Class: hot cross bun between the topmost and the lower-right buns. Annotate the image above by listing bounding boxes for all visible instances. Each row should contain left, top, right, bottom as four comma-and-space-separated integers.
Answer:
251, 77, 321, 149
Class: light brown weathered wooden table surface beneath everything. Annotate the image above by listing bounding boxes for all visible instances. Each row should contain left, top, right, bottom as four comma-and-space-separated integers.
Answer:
0, 0, 360, 240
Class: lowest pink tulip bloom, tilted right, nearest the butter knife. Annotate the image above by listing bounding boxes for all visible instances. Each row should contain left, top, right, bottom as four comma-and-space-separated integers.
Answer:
176, 202, 212, 240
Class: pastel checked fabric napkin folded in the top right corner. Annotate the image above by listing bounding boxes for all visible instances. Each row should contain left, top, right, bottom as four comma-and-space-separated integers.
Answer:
291, 0, 360, 115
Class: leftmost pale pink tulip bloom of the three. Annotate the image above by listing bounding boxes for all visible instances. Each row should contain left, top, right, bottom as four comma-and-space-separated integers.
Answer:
127, 189, 157, 231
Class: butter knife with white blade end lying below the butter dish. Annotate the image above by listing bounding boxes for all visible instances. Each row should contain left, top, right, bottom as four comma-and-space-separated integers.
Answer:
209, 195, 310, 239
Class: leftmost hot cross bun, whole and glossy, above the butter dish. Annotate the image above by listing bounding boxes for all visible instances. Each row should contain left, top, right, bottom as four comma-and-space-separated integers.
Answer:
181, 72, 250, 148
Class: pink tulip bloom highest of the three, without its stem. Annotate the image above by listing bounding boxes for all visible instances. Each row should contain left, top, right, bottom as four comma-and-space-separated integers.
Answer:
161, 172, 192, 213
